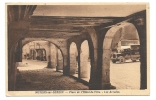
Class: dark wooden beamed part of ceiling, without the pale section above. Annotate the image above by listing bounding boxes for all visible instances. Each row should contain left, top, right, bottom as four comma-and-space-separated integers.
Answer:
29, 16, 121, 39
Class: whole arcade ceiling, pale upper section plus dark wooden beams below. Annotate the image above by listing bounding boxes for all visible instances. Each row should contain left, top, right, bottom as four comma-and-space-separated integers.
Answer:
22, 5, 146, 39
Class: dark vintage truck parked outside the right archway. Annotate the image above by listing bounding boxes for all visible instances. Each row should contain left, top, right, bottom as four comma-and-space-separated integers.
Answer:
111, 45, 140, 63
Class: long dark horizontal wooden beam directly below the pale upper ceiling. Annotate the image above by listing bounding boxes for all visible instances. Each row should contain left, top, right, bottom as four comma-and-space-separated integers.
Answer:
31, 16, 114, 27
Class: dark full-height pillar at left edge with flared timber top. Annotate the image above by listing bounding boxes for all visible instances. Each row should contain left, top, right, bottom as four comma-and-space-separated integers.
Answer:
7, 5, 36, 91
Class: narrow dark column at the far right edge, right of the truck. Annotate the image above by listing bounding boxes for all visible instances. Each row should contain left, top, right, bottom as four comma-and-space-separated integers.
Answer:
133, 16, 147, 89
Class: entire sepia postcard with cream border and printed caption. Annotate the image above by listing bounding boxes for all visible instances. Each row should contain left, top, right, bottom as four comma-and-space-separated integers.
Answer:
5, 2, 150, 96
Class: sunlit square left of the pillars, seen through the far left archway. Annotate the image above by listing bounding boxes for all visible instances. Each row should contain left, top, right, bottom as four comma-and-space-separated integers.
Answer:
18, 41, 50, 70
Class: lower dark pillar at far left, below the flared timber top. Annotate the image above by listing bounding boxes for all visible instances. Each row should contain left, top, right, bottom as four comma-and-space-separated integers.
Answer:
8, 29, 27, 91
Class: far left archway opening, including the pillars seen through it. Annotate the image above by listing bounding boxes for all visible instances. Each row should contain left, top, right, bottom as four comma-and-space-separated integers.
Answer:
19, 40, 63, 71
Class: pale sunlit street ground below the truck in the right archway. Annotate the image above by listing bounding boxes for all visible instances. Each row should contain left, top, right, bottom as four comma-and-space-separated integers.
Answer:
110, 60, 140, 89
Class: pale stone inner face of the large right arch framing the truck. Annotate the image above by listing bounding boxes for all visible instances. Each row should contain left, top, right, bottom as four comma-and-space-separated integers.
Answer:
102, 22, 139, 89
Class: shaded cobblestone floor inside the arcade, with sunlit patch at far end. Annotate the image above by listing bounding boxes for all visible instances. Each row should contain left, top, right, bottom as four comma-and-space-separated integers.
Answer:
17, 61, 88, 91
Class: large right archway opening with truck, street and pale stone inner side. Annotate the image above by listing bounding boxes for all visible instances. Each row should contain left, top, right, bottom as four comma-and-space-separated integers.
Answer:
102, 22, 140, 89
